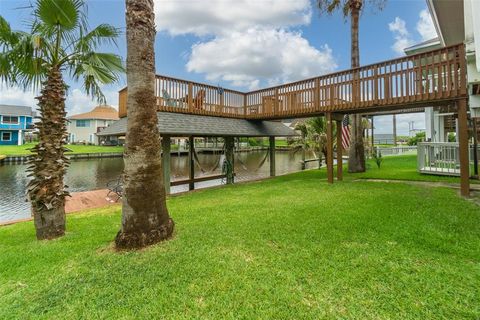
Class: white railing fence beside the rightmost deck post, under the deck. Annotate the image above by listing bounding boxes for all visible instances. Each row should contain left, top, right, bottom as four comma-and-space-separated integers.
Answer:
417, 142, 480, 176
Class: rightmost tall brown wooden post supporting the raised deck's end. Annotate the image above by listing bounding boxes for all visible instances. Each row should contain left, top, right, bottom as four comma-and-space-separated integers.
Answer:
457, 99, 470, 197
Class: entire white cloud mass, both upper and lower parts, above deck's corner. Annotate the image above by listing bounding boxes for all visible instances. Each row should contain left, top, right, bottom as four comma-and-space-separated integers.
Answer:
155, 0, 337, 89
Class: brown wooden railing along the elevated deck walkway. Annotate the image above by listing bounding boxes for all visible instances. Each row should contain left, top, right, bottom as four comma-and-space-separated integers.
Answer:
120, 44, 467, 119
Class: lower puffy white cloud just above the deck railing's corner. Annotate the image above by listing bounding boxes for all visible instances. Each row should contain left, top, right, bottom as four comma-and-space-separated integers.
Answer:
187, 28, 337, 89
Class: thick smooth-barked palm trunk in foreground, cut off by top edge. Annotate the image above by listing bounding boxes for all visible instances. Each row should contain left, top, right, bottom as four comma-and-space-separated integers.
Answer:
115, 0, 174, 249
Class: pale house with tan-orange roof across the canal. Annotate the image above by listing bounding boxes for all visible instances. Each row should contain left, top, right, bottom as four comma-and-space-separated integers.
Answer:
67, 105, 119, 144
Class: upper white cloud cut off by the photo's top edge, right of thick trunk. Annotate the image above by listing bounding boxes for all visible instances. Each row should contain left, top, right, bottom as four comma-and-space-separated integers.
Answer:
155, 0, 312, 36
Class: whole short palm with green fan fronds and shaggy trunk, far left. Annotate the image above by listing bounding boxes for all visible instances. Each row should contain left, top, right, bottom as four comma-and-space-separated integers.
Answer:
0, 0, 124, 239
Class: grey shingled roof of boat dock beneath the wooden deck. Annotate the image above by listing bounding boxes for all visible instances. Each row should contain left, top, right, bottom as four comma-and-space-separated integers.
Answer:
97, 112, 296, 137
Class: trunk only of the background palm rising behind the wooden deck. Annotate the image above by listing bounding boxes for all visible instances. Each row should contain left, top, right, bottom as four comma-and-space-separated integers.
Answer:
348, 0, 365, 172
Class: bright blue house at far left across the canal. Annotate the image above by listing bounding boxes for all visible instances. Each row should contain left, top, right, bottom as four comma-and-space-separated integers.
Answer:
0, 104, 35, 145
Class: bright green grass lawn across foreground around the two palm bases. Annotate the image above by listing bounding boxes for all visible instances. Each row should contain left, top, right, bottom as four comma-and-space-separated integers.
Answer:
0, 171, 480, 319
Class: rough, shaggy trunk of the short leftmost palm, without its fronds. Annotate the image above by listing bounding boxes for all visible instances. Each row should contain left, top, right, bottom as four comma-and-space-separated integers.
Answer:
28, 67, 68, 240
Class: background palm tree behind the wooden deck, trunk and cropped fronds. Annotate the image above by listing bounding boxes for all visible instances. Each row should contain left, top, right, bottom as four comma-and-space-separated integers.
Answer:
317, 0, 386, 172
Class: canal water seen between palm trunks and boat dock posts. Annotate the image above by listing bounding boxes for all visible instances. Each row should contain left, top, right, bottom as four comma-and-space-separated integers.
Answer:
0, 150, 318, 222
